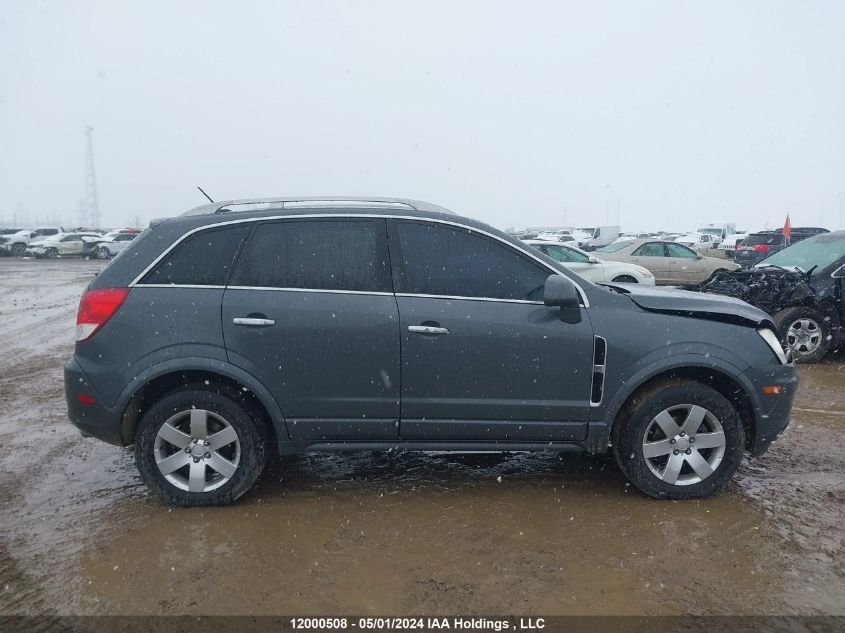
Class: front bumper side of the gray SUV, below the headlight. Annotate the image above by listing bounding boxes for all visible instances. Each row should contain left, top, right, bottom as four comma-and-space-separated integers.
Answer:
744, 365, 798, 456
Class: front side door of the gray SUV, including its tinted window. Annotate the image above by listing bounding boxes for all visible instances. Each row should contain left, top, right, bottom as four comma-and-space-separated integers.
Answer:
390, 220, 593, 441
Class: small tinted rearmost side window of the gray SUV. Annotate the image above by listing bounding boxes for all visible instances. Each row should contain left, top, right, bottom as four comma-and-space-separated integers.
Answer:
141, 224, 250, 286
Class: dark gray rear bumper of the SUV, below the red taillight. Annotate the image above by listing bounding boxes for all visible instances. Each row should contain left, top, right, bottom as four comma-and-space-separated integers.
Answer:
65, 359, 126, 446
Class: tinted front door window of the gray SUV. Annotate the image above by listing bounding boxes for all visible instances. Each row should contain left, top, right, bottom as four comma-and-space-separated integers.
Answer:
396, 222, 551, 301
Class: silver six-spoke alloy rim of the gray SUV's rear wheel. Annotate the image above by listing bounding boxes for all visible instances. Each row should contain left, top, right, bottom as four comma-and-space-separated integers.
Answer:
153, 409, 241, 492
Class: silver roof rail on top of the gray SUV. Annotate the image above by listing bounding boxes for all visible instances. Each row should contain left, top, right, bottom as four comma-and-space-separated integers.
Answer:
182, 196, 453, 215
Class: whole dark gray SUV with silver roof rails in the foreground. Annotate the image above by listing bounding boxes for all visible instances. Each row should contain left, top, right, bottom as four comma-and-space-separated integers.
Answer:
65, 198, 797, 506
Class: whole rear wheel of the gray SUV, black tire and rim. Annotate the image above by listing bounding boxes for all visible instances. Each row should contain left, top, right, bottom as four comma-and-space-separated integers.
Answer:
135, 387, 268, 507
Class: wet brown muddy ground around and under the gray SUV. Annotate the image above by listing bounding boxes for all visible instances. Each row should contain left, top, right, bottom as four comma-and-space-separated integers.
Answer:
0, 258, 845, 615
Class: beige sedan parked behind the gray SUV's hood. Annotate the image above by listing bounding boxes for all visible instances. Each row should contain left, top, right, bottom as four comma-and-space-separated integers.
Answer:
596, 240, 739, 285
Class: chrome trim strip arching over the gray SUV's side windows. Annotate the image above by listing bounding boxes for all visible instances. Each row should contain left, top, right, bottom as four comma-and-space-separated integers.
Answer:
129, 213, 590, 308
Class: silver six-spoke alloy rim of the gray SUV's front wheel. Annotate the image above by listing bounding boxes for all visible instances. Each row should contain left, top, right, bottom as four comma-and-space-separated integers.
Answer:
642, 404, 726, 486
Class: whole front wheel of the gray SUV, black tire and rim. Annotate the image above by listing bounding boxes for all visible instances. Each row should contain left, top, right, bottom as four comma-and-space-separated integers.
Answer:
612, 379, 745, 499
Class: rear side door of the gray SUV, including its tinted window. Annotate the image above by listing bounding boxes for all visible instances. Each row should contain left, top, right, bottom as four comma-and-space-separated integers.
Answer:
222, 217, 400, 441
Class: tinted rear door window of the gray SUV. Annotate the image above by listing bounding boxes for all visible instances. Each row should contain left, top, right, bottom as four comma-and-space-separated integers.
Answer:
232, 219, 392, 292
